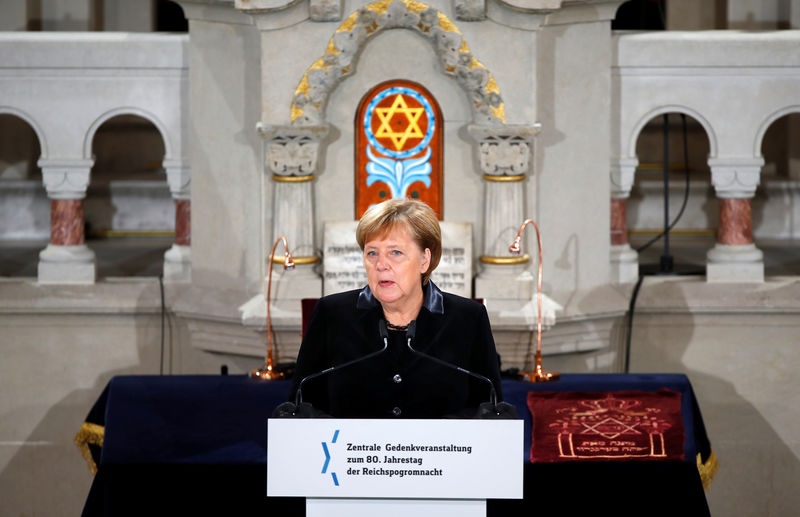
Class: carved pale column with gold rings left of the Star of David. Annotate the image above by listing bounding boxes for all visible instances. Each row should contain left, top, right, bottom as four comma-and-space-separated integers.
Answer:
258, 124, 328, 305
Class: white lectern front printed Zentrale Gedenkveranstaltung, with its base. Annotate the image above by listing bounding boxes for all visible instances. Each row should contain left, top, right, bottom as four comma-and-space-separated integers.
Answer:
267, 418, 524, 517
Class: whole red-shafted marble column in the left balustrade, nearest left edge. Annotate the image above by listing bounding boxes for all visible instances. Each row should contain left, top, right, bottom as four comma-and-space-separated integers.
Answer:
38, 160, 97, 284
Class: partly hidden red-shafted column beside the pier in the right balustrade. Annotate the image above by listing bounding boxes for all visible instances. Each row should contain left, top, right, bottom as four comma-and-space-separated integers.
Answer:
609, 158, 639, 284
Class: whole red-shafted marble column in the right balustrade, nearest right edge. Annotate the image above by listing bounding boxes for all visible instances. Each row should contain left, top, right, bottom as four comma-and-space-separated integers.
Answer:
706, 157, 764, 282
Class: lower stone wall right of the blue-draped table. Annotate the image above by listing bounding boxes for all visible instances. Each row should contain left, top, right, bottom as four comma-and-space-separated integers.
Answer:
631, 277, 800, 517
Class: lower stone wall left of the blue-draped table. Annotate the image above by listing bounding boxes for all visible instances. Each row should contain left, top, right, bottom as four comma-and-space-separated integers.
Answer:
0, 279, 177, 515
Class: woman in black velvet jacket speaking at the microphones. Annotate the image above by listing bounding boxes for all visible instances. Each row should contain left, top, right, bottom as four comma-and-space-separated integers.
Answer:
290, 199, 502, 418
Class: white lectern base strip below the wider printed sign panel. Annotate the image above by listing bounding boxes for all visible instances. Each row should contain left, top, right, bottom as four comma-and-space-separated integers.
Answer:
306, 497, 486, 517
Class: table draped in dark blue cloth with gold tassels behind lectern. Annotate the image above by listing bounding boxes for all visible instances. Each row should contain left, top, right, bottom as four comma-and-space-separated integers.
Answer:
76, 374, 715, 516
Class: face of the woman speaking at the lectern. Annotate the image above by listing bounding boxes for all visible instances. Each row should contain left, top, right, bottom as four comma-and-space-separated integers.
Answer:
364, 225, 431, 309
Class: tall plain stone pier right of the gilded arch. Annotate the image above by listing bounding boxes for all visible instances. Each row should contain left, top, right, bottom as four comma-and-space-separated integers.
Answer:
527, 22, 612, 298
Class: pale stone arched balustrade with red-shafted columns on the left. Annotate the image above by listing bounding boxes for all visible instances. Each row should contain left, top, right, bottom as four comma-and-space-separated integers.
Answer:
0, 32, 191, 283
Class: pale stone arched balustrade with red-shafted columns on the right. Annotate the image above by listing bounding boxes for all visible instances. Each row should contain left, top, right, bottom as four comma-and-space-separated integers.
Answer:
611, 31, 800, 282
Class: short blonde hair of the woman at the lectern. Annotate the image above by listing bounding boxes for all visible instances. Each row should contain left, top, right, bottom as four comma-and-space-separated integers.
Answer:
356, 198, 442, 285
